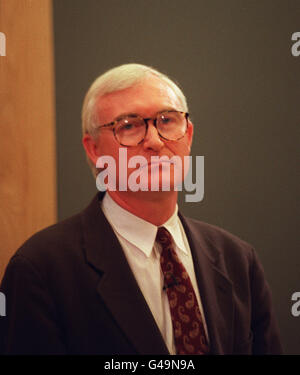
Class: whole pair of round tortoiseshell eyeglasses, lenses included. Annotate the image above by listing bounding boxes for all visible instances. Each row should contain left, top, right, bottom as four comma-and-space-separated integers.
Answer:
97, 110, 189, 147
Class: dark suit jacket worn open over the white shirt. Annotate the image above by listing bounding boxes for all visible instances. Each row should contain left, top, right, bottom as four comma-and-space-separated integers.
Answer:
0, 194, 281, 354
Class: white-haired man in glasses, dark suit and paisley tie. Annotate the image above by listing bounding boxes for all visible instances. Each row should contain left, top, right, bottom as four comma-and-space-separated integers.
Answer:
0, 64, 281, 354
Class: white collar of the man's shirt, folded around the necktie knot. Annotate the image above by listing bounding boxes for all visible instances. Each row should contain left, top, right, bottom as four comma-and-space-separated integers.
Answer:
102, 193, 187, 257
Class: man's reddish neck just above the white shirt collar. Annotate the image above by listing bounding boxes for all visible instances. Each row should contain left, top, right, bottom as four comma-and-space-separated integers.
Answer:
108, 191, 178, 226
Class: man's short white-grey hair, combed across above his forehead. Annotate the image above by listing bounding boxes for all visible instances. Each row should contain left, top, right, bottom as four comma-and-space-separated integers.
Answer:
82, 64, 188, 176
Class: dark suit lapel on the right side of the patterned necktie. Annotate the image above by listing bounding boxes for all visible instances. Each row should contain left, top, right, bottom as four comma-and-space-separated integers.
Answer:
180, 215, 234, 354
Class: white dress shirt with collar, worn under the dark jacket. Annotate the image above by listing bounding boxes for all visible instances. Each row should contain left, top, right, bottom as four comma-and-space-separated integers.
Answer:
102, 193, 208, 354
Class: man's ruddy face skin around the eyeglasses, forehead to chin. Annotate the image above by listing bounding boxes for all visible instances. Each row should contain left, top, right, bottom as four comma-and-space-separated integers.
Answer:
89, 76, 193, 194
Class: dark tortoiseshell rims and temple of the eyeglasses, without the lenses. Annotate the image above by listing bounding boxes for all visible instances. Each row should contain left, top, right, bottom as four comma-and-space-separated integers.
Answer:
95, 109, 189, 147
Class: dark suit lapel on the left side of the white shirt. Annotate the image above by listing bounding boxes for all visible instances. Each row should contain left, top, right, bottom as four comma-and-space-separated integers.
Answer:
82, 194, 169, 355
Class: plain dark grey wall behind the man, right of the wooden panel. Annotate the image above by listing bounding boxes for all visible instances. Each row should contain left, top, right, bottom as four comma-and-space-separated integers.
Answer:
54, 0, 300, 354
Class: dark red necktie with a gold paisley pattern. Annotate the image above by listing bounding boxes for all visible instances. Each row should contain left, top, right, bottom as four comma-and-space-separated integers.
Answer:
156, 227, 209, 354
